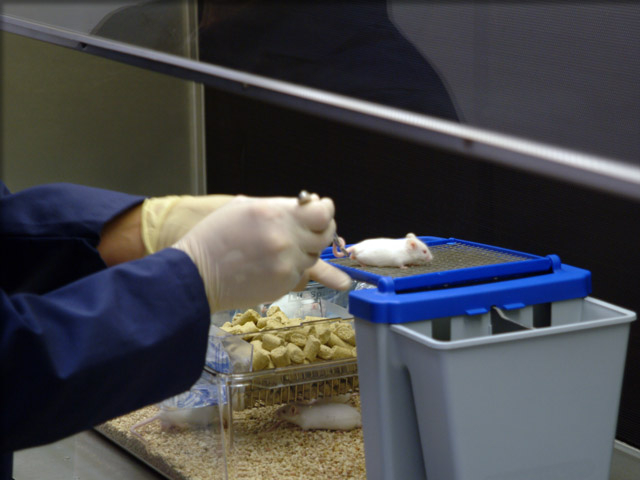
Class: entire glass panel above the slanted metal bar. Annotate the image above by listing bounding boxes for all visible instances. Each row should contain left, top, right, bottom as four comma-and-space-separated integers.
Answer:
4, 0, 640, 167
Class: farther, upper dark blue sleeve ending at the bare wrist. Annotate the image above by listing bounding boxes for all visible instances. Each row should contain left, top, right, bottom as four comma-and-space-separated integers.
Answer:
0, 183, 144, 294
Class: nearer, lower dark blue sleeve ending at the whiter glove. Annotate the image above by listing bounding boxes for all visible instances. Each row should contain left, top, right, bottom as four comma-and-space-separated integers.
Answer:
0, 249, 210, 452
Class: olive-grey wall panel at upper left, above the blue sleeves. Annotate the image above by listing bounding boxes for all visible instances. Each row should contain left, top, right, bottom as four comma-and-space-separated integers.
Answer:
0, 2, 205, 195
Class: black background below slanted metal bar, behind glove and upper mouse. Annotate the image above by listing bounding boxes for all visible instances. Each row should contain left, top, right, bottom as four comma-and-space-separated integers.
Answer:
206, 89, 640, 447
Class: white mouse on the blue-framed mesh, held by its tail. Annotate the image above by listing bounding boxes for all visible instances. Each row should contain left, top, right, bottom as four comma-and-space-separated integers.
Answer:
333, 233, 433, 268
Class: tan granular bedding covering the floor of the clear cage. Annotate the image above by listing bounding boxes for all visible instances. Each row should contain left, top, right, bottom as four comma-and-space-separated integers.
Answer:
97, 395, 366, 480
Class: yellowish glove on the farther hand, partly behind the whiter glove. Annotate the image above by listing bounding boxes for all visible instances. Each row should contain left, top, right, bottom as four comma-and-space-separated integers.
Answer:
141, 195, 235, 254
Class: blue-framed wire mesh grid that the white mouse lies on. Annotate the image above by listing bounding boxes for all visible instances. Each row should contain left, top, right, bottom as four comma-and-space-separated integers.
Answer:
325, 237, 552, 292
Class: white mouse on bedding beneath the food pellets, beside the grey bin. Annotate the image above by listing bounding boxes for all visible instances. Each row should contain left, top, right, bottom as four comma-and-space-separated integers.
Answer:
276, 402, 362, 430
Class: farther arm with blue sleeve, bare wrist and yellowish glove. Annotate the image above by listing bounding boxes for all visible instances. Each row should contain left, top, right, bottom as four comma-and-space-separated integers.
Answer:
0, 182, 234, 286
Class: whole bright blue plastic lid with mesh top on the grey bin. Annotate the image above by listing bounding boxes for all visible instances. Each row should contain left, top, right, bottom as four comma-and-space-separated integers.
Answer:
322, 237, 591, 323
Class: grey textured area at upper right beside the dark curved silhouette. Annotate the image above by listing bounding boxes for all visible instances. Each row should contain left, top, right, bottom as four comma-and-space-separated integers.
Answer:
389, 0, 640, 163
